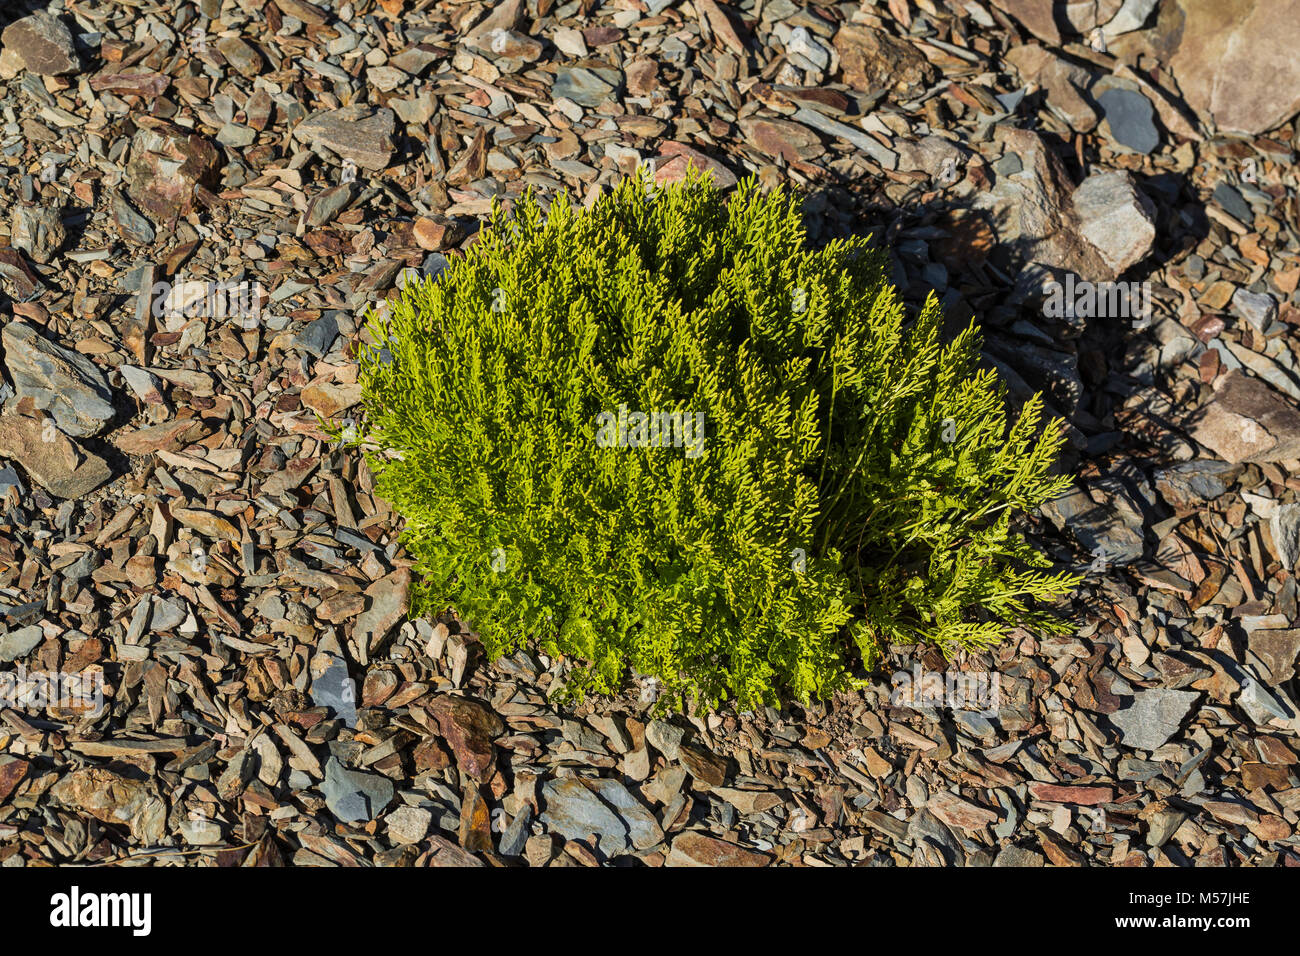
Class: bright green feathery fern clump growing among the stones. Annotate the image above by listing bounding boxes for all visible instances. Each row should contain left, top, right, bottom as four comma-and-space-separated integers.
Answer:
358, 176, 1075, 706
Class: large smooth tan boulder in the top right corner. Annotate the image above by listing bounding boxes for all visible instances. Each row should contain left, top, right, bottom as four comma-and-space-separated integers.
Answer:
1162, 0, 1300, 135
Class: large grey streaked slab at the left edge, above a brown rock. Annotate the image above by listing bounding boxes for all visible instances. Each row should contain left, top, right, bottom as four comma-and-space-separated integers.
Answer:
0, 321, 116, 438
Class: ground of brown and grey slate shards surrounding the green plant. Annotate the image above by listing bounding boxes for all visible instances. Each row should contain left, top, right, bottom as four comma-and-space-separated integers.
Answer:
0, 0, 1300, 866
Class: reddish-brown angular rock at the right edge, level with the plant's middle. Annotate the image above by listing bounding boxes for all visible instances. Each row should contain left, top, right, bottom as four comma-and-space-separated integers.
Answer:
1188, 369, 1300, 464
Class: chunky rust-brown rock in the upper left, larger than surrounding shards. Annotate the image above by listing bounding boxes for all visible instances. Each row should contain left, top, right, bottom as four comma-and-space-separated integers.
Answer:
126, 120, 220, 224
